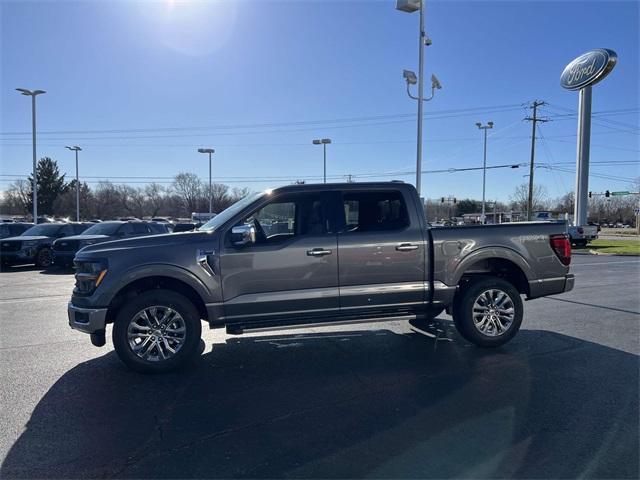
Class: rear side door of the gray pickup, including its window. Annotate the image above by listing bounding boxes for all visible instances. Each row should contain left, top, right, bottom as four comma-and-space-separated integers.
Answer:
338, 189, 428, 313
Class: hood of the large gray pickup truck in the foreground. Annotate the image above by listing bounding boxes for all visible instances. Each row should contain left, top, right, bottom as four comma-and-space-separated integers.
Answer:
79, 232, 214, 256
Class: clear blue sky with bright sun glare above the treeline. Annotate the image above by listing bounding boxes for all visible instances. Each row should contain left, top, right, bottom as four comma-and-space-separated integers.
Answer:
0, 0, 640, 201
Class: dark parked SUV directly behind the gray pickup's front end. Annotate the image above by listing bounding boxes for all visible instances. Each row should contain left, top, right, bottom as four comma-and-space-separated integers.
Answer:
53, 221, 169, 266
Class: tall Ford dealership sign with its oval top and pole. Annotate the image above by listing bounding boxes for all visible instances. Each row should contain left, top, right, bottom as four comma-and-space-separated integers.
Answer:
560, 48, 618, 226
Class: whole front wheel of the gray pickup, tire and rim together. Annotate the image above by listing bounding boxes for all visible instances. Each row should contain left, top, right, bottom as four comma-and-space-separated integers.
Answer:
113, 290, 202, 373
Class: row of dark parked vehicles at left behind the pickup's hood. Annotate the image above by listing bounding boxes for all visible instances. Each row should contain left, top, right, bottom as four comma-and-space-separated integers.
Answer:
0, 220, 199, 268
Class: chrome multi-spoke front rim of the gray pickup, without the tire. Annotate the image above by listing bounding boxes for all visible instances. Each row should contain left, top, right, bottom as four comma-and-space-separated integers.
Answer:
127, 305, 187, 362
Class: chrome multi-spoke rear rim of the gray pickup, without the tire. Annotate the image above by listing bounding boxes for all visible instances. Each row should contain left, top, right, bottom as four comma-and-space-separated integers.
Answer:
473, 288, 515, 337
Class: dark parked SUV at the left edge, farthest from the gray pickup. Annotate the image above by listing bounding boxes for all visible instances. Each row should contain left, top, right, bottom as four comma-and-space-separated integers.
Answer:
0, 223, 91, 268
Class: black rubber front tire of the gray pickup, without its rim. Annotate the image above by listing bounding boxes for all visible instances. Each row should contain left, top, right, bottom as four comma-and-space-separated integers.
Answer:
112, 290, 202, 373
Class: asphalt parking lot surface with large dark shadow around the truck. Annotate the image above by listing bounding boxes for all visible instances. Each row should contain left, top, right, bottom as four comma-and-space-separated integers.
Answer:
0, 255, 640, 478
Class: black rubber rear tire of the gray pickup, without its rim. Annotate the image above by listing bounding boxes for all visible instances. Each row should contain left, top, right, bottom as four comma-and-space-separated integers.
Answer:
453, 277, 523, 347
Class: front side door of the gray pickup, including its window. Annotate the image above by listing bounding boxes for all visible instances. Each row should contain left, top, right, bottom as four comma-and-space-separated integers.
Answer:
220, 192, 339, 323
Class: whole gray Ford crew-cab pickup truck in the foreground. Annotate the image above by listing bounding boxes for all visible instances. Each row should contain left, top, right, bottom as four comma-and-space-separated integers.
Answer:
68, 182, 574, 372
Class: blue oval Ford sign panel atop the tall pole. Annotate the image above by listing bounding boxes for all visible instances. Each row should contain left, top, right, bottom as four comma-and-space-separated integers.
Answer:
560, 48, 618, 90
